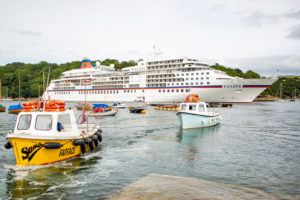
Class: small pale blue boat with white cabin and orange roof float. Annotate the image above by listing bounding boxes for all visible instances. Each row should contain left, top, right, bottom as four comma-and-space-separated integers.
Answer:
177, 102, 221, 129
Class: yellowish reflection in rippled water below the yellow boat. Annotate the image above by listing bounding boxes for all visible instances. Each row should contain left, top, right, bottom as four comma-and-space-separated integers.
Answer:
5, 154, 101, 199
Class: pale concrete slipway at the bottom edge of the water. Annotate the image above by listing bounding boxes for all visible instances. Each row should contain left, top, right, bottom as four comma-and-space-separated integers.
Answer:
108, 174, 300, 200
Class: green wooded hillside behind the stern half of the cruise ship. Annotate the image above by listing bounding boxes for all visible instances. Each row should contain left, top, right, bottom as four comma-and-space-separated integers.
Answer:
0, 59, 136, 98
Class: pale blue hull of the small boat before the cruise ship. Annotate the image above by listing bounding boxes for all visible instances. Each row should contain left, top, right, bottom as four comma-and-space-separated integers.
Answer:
178, 112, 220, 129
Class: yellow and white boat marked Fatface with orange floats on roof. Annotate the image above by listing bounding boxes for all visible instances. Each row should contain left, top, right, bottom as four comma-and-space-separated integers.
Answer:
5, 101, 102, 166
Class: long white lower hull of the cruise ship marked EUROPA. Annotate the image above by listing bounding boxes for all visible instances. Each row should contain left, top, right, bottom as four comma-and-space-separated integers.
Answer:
45, 79, 276, 104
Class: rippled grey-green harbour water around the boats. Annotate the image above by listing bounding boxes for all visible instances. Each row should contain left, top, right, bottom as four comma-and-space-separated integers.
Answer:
0, 101, 300, 199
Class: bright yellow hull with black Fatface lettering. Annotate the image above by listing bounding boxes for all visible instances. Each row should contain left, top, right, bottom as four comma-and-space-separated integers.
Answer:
9, 138, 90, 166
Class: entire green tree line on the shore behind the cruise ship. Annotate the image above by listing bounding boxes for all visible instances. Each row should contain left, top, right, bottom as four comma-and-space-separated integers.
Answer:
0, 59, 300, 98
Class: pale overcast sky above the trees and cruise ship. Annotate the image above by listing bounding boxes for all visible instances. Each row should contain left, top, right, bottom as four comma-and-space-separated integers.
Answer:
0, 0, 300, 76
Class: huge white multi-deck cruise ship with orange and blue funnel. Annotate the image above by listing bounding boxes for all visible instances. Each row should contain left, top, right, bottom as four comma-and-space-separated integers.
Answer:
44, 58, 276, 104
